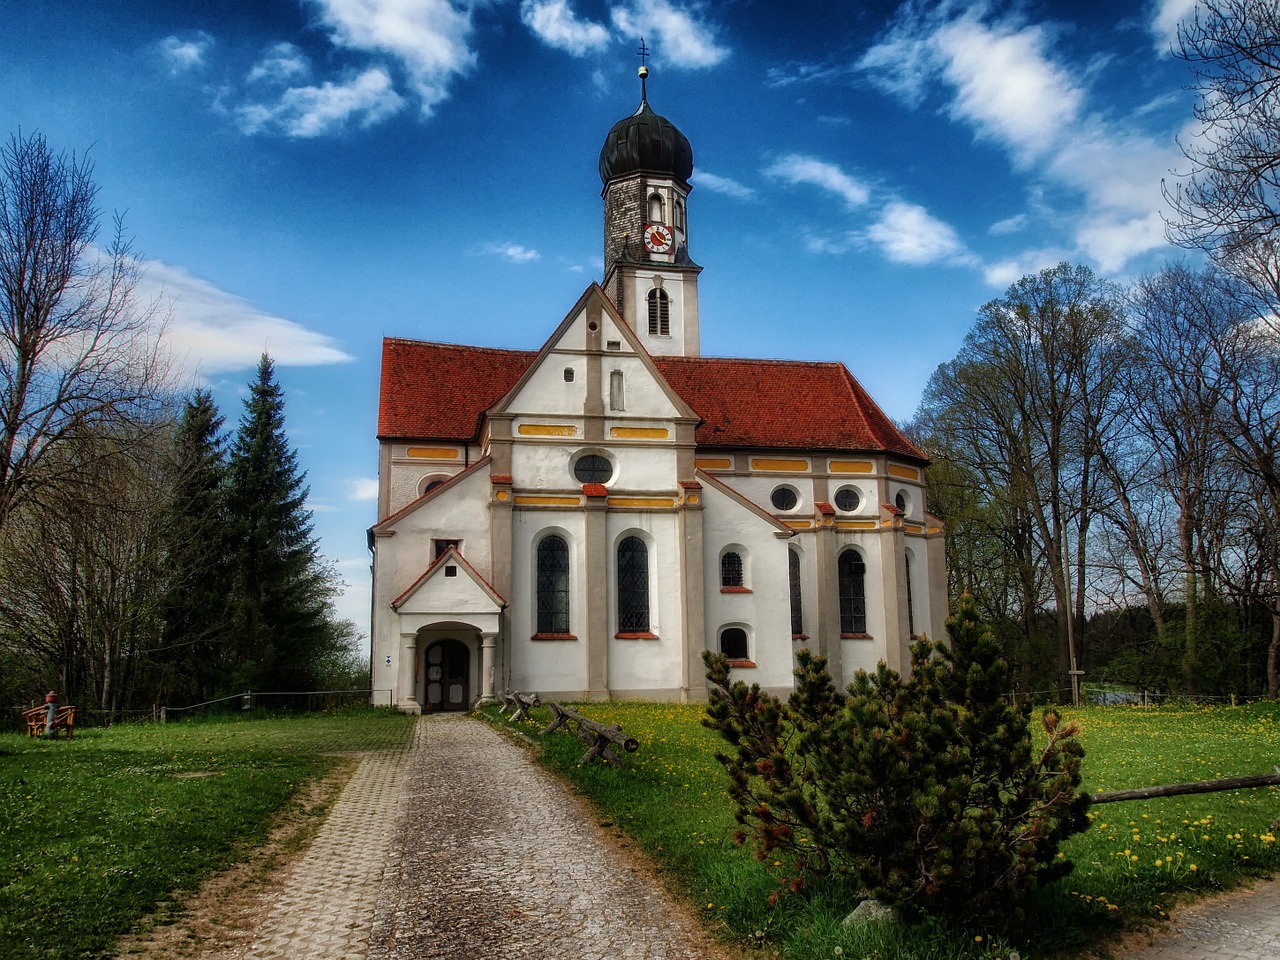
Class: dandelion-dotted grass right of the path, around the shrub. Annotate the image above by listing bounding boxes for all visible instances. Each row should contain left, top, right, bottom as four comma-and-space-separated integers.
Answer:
495, 703, 1280, 960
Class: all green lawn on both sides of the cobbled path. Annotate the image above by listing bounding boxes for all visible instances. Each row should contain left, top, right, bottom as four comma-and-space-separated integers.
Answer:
0, 703, 1280, 960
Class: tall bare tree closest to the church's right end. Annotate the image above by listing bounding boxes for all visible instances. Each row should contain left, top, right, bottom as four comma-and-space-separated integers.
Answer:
920, 264, 1126, 701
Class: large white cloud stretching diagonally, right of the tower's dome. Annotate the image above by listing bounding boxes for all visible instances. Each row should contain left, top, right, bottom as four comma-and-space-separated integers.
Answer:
858, 0, 1184, 279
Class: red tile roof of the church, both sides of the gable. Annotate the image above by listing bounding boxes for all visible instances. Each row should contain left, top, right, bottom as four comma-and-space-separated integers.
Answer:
378, 338, 925, 461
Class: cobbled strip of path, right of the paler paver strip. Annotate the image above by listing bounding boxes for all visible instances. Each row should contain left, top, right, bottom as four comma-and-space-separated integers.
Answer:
369, 714, 722, 960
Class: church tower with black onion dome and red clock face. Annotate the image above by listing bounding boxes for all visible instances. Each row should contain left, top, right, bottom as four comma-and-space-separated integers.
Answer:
600, 65, 703, 357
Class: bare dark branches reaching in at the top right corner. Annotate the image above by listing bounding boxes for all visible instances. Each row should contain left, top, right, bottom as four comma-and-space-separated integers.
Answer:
1165, 0, 1280, 310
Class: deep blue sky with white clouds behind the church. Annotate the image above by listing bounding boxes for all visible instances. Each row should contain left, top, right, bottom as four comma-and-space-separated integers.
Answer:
0, 0, 1194, 642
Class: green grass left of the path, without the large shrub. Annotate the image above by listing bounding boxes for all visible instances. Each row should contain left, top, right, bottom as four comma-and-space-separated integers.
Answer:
0, 709, 412, 960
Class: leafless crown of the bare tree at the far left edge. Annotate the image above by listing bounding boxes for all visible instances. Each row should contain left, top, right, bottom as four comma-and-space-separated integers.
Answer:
0, 133, 164, 529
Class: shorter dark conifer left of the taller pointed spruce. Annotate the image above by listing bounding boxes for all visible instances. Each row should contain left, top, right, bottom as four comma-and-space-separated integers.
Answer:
156, 390, 234, 703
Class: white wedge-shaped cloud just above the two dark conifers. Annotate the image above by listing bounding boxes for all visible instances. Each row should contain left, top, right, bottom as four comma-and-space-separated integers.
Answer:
138, 260, 353, 376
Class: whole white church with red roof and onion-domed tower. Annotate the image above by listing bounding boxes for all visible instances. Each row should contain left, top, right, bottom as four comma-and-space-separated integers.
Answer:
369, 67, 947, 713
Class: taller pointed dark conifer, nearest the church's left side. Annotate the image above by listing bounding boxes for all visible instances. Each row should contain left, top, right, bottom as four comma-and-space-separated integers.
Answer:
229, 353, 333, 690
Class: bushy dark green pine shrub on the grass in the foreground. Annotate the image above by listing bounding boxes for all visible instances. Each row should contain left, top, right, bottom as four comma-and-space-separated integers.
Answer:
704, 598, 1088, 922
